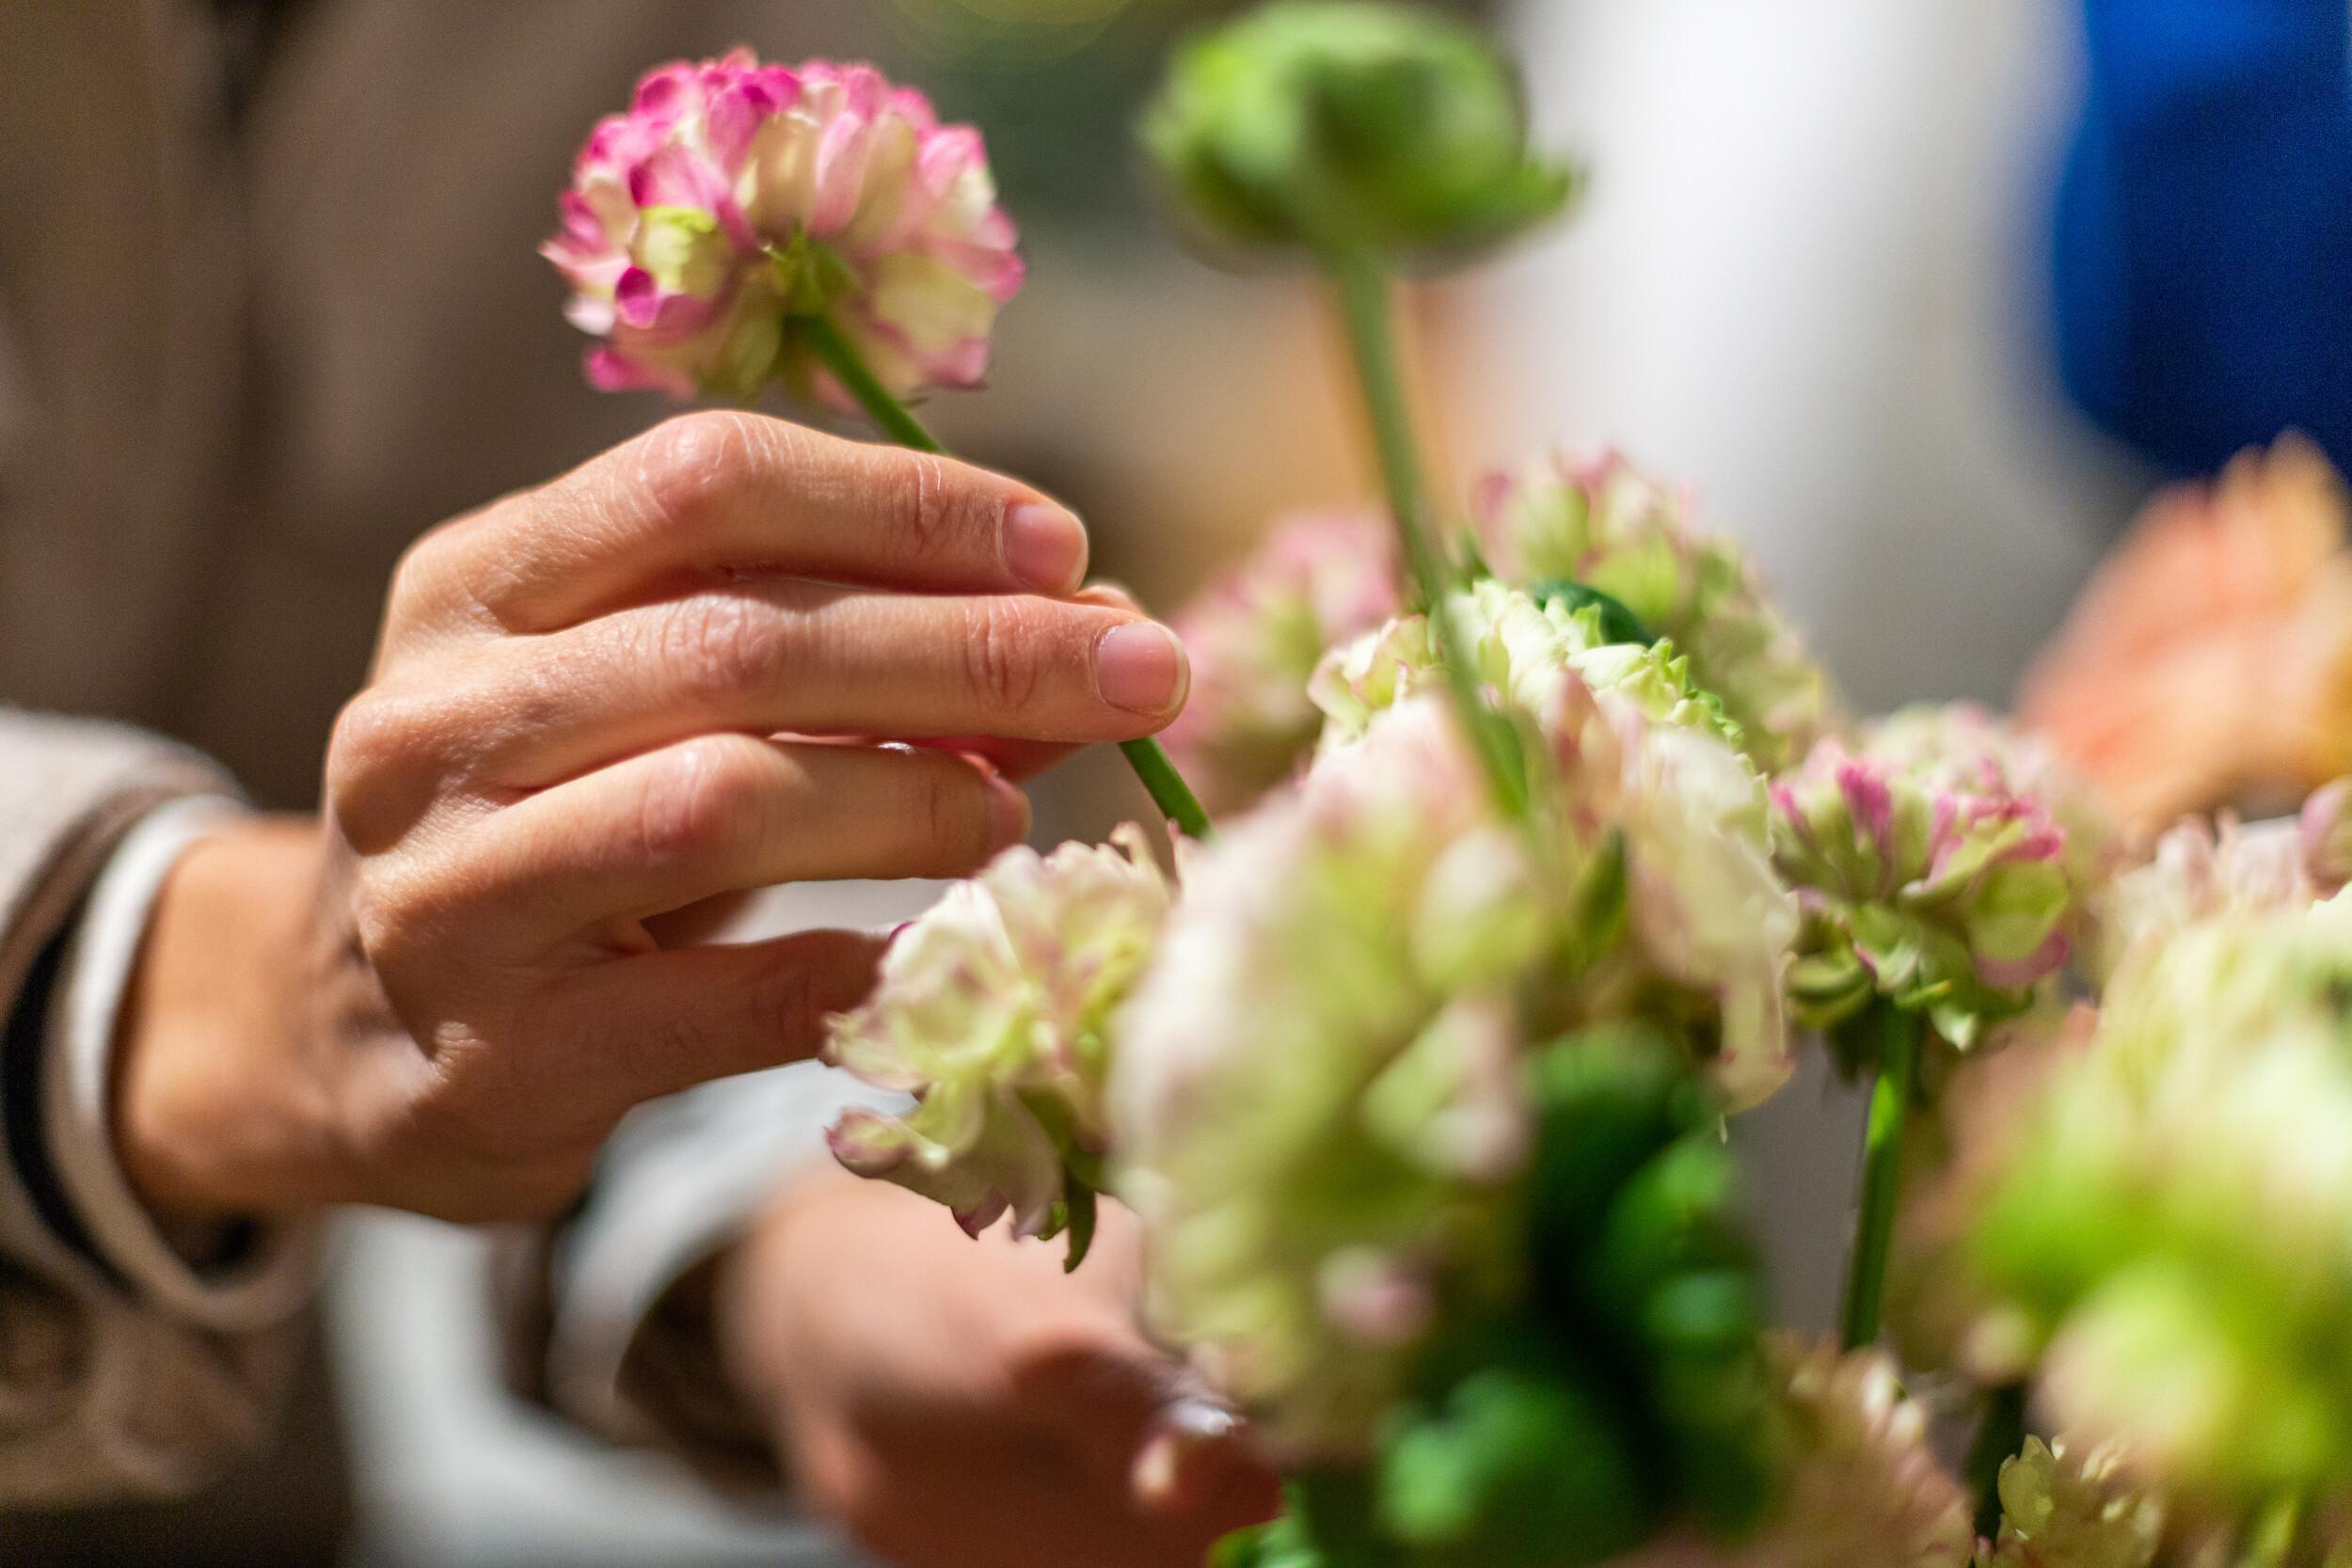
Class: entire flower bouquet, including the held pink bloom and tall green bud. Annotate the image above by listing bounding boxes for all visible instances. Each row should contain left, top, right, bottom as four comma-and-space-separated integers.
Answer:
546, 0, 2352, 1568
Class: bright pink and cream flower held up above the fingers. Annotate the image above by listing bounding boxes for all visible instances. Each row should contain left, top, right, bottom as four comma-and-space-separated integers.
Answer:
555, 49, 1024, 409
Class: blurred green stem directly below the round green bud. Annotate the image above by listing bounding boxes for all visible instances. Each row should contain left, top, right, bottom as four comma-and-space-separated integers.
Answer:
1325, 246, 1527, 818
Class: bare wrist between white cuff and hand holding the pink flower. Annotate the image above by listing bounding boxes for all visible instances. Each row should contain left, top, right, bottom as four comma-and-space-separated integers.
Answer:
111, 818, 342, 1223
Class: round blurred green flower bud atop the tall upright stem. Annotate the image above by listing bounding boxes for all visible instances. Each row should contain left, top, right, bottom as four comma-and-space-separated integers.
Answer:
1141, 0, 1579, 265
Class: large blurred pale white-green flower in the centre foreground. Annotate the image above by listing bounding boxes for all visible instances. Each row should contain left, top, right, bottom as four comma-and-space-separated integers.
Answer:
1110, 698, 1548, 1453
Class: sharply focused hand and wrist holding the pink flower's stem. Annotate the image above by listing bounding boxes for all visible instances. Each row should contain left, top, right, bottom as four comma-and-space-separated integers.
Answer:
116, 414, 1185, 1220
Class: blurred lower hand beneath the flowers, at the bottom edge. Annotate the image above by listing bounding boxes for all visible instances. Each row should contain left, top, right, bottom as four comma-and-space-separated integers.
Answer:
718, 1166, 1279, 1568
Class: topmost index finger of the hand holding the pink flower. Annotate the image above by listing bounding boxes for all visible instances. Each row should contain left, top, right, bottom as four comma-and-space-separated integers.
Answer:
407, 414, 1087, 632
